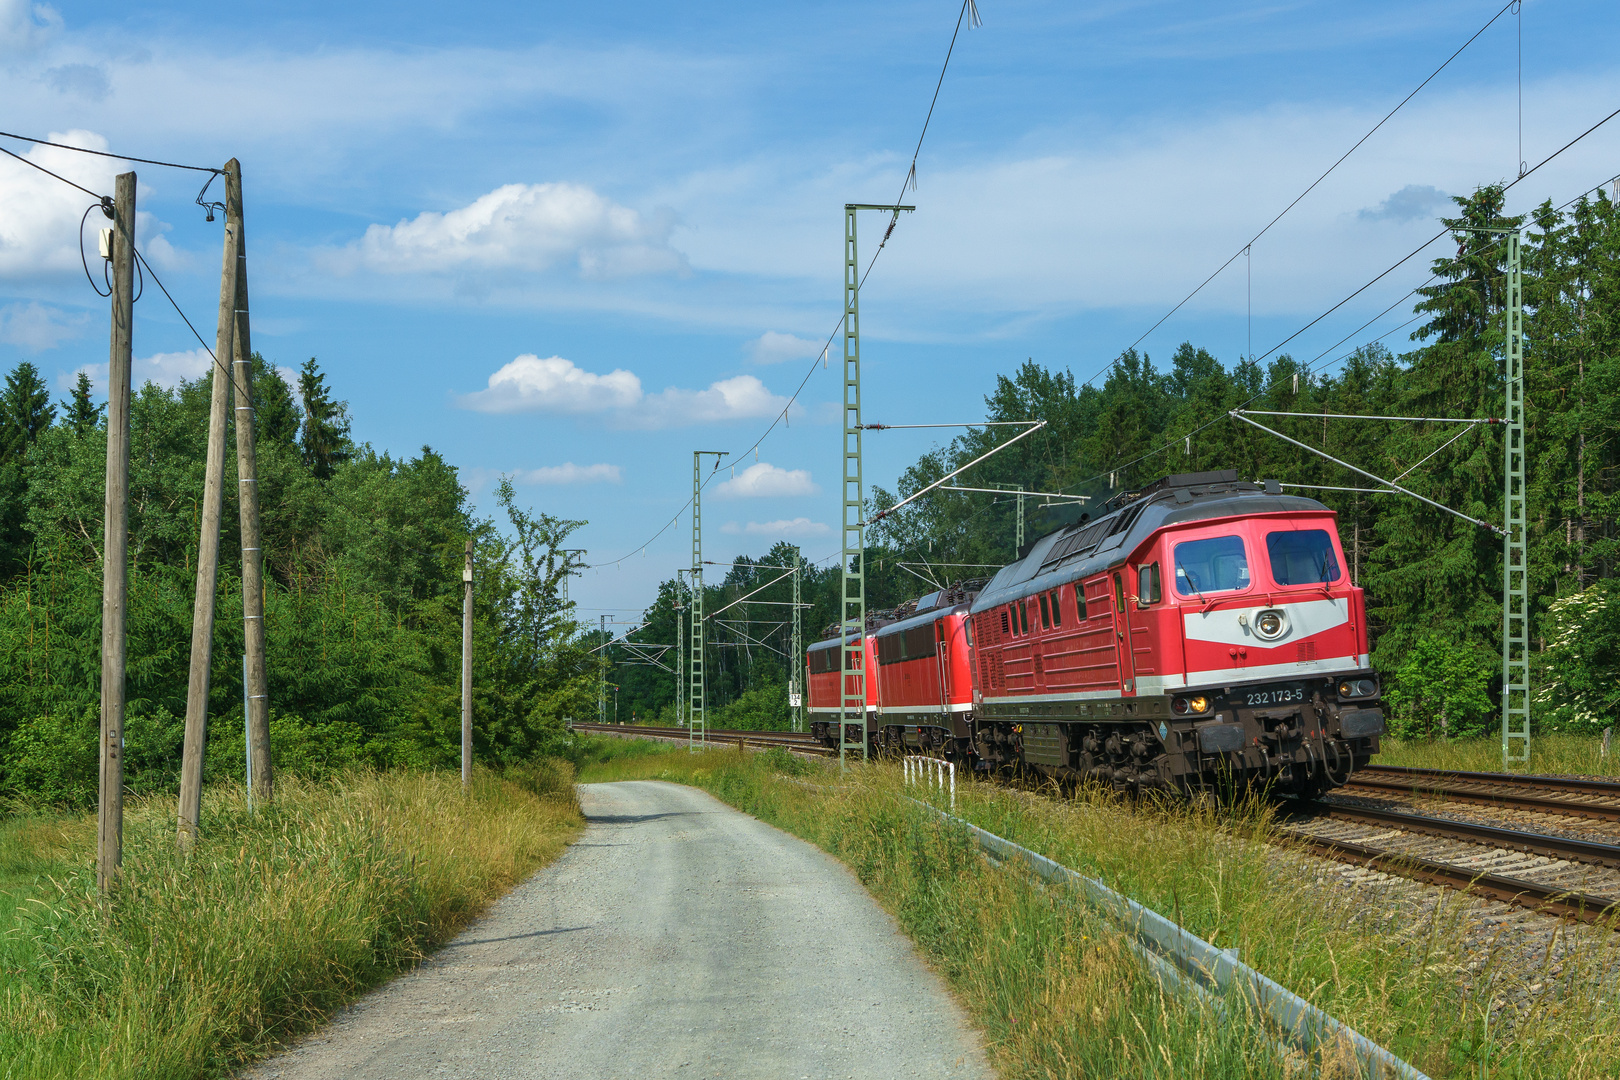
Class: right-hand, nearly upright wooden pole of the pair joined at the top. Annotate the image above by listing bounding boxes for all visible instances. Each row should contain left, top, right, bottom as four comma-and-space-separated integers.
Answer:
225, 159, 274, 803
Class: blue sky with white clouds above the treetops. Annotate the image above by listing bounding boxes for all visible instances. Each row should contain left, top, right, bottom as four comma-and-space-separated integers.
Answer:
0, 0, 1620, 622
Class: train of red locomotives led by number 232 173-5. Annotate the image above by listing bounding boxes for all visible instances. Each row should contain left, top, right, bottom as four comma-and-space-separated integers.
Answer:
810, 471, 1383, 797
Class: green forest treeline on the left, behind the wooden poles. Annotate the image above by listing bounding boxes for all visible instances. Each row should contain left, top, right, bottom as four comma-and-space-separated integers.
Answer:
0, 355, 596, 805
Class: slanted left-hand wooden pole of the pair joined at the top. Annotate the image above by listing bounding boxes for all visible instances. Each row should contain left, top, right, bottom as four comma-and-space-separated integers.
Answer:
180, 159, 241, 850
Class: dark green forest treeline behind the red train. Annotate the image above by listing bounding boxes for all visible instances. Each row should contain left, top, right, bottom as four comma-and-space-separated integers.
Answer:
616, 186, 1620, 735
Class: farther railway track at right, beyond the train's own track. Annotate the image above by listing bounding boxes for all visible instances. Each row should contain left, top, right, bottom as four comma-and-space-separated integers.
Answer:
1338, 766, 1620, 821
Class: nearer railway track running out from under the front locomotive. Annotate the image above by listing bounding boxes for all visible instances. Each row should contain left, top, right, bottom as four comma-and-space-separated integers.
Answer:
1283, 801, 1620, 929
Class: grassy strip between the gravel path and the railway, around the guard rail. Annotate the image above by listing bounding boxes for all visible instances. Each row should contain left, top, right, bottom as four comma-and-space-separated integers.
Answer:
582, 738, 1620, 1080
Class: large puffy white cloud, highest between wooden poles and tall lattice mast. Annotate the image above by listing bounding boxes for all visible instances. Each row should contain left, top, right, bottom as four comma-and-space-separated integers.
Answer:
324, 183, 687, 279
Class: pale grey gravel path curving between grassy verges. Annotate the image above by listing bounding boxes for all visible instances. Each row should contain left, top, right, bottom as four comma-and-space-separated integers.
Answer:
246, 782, 993, 1080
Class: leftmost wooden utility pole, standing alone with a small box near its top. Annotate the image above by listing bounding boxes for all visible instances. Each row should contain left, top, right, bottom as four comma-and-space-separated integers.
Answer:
96, 173, 134, 892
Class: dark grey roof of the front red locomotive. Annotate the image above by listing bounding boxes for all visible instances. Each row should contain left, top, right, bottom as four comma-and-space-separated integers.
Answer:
972, 470, 1327, 612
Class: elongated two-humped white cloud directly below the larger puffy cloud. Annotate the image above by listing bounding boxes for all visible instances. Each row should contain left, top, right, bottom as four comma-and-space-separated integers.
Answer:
460, 353, 787, 427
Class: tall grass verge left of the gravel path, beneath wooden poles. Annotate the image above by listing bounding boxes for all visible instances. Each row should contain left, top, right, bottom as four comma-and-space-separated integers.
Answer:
0, 761, 583, 1080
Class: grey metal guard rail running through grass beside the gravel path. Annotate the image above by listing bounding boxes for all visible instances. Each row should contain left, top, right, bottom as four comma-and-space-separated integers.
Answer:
910, 800, 1430, 1080
